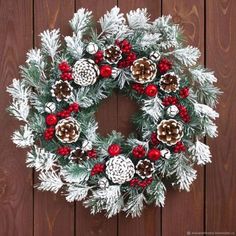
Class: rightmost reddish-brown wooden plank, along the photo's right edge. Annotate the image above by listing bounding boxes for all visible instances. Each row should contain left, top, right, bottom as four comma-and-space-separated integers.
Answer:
206, 0, 236, 235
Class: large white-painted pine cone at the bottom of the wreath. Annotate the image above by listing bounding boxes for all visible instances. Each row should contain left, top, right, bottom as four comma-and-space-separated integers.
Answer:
106, 155, 135, 184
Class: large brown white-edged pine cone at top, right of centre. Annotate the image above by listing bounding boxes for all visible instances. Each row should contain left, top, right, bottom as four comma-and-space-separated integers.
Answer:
130, 57, 157, 84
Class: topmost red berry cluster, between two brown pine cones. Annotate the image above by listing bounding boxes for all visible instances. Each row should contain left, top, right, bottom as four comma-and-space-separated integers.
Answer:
115, 39, 137, 68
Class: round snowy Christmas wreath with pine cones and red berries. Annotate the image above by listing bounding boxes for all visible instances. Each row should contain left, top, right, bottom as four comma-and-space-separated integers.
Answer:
7, 7, 220, 217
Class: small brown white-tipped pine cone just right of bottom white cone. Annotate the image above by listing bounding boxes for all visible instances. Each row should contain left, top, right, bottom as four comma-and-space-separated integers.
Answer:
136, 159, 155, 179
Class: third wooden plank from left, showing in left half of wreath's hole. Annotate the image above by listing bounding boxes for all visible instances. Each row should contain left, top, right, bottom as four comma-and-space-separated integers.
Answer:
76, 0, 117, 236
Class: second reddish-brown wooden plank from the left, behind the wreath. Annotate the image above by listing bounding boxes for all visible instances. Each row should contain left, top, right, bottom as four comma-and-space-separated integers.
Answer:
34, 0, 74, 236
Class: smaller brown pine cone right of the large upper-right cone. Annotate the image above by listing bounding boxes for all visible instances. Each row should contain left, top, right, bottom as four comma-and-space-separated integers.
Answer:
160, 72, 180, 93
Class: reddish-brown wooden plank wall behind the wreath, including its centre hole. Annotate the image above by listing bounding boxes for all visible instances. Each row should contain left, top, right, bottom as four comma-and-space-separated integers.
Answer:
0, 0, 236, 236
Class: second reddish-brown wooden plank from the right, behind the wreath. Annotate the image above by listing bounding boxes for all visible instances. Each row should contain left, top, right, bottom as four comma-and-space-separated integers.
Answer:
162, 0, 204, 235
